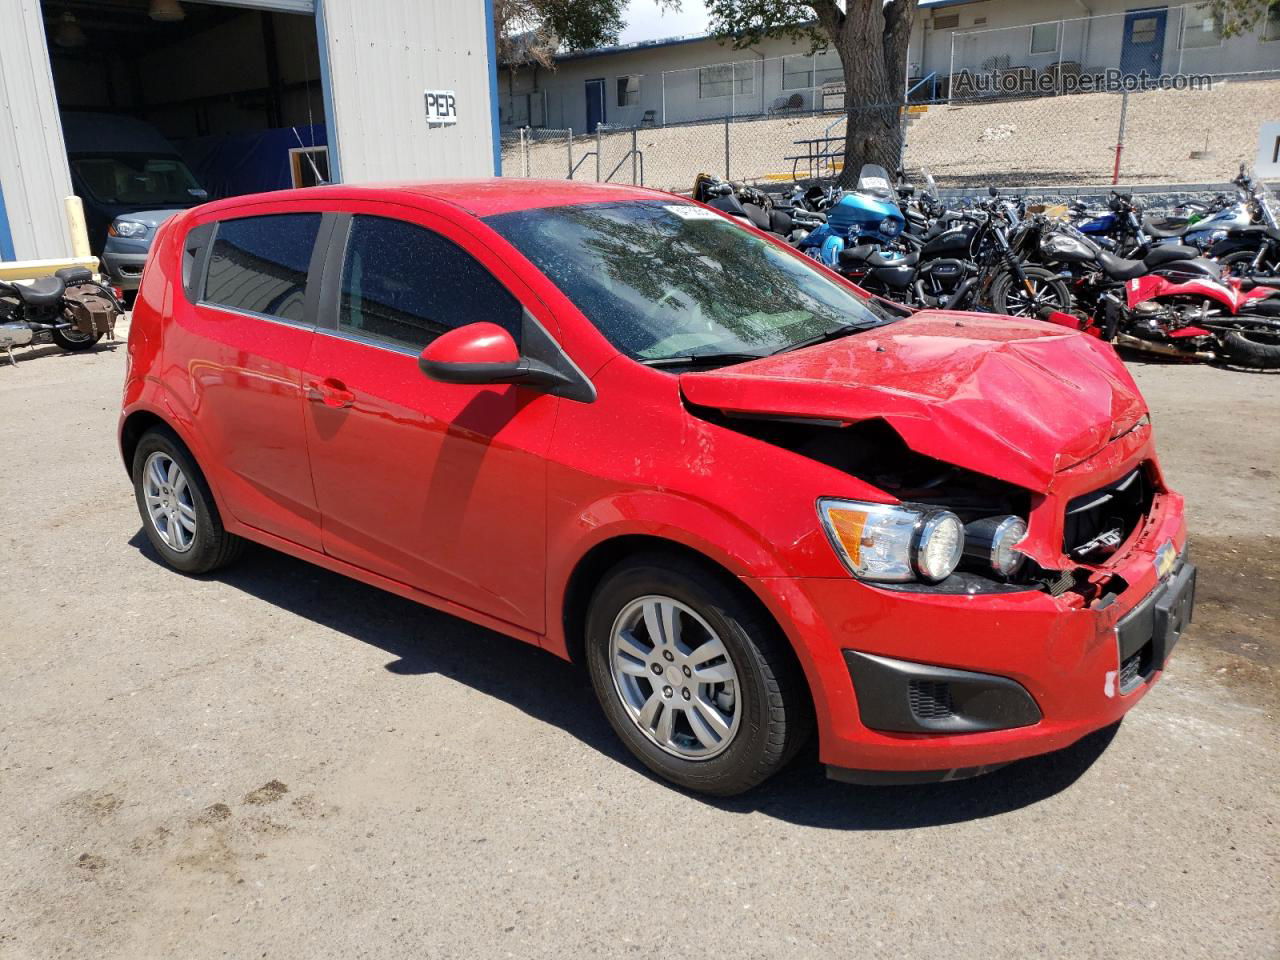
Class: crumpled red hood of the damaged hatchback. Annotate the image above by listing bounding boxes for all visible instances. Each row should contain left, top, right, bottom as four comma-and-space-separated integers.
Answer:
680, 311, 1147, 493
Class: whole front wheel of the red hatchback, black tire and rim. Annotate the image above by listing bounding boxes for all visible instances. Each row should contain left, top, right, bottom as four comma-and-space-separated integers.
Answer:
585, 554, 813, 796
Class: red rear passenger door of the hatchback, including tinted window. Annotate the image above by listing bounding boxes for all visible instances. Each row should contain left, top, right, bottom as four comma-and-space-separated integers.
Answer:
164, 204, 323, 549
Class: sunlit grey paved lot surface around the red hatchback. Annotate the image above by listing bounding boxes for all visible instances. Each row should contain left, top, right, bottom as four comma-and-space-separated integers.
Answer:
0, 335, 1280, 960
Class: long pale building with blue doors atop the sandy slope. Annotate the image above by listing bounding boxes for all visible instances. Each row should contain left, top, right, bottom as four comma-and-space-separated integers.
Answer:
498, 0, 1280, 133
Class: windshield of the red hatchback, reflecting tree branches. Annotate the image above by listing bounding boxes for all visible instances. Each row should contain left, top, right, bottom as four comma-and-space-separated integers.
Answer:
485, 201, 883, 362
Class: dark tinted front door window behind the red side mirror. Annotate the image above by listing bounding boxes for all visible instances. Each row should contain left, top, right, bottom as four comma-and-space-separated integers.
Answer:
338, 216, 522, 351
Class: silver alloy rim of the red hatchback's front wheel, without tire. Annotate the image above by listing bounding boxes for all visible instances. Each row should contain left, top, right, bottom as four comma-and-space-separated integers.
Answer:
609, 595, 741, 760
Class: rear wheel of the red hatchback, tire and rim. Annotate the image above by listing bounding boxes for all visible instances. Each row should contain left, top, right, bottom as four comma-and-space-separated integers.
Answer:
133, 428, 244, 573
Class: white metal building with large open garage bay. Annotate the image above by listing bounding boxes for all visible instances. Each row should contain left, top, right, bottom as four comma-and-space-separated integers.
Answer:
0, 0, 500, 261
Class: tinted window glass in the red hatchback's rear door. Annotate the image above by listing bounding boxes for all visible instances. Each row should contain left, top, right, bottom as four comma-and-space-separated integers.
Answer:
204, 214, 320, 323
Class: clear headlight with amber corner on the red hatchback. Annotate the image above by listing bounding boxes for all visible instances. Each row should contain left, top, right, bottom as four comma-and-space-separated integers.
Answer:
818, 499, 964, 582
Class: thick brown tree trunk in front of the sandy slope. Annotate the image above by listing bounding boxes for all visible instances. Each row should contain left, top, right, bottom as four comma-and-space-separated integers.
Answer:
814, 0, 916, 187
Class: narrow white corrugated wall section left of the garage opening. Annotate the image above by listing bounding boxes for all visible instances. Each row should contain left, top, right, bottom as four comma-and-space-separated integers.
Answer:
0, 0, 72, 260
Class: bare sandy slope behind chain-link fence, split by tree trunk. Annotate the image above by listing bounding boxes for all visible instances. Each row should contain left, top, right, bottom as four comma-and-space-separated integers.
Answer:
503, 73, 1280, 192
